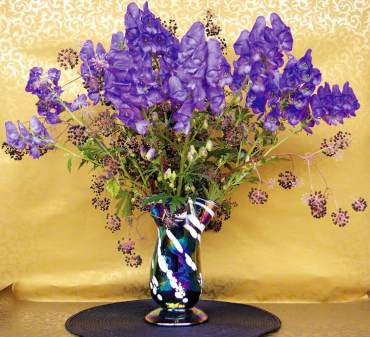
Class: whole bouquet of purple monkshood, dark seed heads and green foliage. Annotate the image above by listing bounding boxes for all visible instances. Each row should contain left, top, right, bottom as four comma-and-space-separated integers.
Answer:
3, 3, 367, 267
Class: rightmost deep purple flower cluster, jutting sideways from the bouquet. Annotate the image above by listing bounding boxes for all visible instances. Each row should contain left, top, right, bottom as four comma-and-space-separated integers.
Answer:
310, 82, 360, 125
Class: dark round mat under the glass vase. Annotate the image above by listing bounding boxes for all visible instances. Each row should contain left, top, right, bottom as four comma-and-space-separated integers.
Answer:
66, 300, 281, 337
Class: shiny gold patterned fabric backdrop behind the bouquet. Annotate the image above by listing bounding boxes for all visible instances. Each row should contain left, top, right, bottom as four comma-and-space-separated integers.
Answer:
0, 0, 370, 301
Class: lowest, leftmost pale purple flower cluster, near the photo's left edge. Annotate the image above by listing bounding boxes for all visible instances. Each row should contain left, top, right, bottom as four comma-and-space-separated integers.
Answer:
5, 116, 54, 159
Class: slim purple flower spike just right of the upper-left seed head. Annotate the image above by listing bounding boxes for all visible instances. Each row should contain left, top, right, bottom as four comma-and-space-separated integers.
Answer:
80, 40, 108, 105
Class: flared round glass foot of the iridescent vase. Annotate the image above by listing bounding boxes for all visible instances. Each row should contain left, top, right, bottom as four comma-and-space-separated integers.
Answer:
145, 307, 208, 327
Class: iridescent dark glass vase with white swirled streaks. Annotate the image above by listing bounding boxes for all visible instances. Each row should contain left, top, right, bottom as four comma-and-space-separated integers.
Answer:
145, 198, 215, 326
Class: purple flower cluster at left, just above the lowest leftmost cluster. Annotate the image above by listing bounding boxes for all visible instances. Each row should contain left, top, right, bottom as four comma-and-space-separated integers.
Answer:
25, 67, 65, 124
